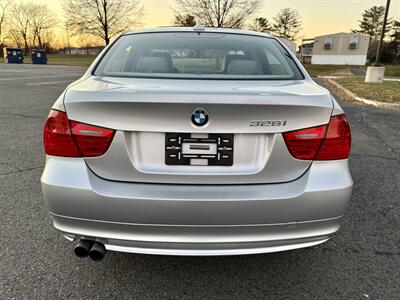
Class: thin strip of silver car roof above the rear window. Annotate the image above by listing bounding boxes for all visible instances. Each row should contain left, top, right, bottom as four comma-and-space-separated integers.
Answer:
122, 26, 273, 38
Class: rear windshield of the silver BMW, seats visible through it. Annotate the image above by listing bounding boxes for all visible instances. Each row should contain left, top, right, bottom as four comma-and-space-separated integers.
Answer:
95, 32, 303, 80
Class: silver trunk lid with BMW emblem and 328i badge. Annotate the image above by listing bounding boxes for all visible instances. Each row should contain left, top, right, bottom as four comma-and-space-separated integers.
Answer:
64, 77, 332, 184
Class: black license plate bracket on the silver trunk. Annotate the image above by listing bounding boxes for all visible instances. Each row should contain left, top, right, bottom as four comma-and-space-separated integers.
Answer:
165, 133, 233, 166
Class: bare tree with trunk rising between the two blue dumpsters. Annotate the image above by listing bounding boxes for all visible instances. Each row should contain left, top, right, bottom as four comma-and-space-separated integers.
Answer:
7, 2, 35, 52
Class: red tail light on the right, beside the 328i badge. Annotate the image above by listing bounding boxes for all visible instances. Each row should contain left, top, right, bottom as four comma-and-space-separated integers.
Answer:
283, 115, 351, 160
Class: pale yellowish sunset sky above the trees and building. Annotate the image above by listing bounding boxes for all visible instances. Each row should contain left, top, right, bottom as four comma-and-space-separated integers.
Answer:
20, 0, 400, 45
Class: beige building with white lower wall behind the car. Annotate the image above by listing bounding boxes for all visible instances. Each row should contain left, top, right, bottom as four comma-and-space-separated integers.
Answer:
311, 32, 369, 65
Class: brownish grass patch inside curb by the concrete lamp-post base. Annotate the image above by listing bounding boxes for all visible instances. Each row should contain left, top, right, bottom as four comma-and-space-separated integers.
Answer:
335, 77, 400, 103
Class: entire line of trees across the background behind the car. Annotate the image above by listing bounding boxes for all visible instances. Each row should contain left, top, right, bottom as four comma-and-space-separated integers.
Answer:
0, 0, 400, 59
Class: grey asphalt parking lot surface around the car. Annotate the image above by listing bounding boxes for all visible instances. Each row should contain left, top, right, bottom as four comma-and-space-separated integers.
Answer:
0, 64, 400, 299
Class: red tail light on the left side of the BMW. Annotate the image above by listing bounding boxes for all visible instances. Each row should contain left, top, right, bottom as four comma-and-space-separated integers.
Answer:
44, 110, 115, 157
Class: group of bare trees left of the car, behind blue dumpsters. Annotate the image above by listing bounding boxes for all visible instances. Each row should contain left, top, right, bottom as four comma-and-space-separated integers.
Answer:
0, 0, 144, 53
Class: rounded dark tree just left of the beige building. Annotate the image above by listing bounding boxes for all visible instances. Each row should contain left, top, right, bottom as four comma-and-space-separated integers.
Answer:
272, 8, 302, 40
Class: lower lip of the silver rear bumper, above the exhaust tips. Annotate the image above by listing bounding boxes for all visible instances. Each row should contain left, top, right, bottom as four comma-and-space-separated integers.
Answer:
53, 215, 340, 256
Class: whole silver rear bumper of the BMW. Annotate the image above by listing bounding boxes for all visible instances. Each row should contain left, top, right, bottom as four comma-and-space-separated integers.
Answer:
41, 157, 353, 255
